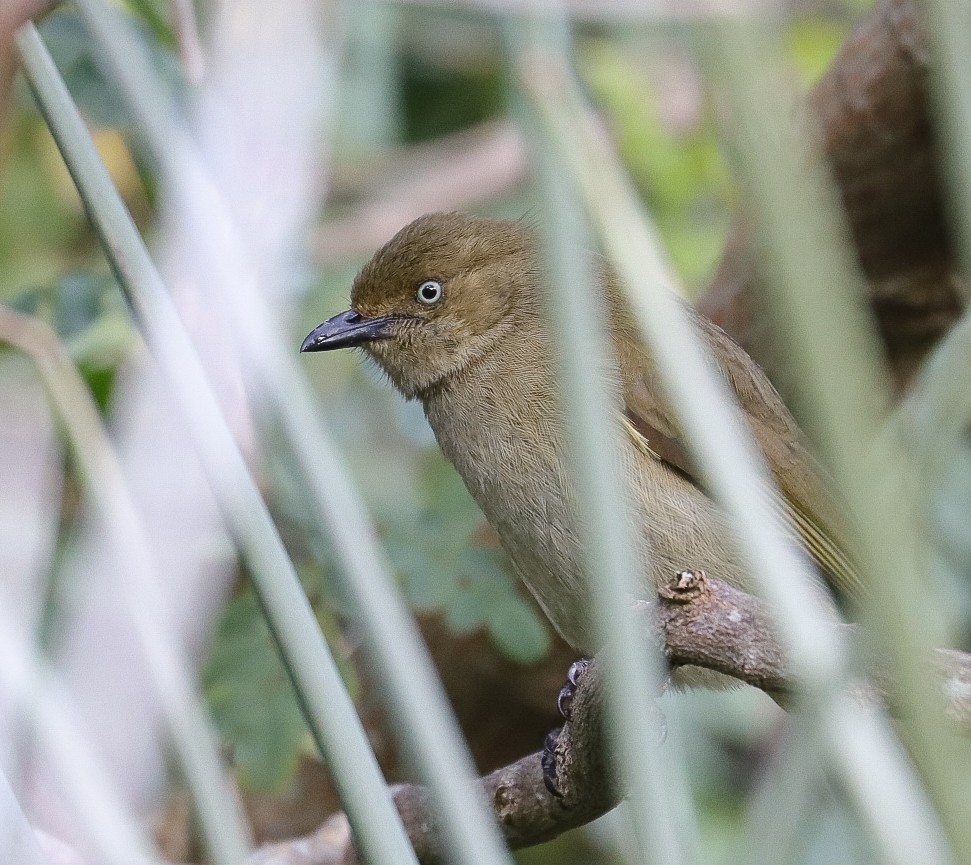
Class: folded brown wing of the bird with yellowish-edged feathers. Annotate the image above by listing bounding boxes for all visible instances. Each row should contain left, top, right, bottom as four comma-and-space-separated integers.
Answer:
616, 308, 864, 602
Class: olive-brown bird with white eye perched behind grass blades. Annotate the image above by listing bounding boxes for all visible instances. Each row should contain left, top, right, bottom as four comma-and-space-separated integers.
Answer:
301, 213, 854, 653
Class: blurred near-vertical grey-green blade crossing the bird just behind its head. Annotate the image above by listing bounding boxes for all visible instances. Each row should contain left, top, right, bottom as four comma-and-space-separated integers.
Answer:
506, 20, 697, 865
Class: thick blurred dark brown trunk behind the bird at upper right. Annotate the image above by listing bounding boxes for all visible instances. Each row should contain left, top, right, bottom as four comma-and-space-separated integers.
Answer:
699, 0, 962, 385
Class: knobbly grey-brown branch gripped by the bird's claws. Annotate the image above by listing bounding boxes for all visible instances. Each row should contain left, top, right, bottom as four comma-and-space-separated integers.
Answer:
251, 571, 971, 865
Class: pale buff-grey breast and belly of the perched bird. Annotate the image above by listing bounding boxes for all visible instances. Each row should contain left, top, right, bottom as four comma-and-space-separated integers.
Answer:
425, 360, 743, 652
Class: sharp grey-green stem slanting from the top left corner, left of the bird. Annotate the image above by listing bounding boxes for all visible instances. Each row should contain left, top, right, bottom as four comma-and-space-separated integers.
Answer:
18, 25, 415, 865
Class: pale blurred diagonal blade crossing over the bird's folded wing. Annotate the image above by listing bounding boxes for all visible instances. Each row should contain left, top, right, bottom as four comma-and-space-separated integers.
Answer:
520, 30, 947, 863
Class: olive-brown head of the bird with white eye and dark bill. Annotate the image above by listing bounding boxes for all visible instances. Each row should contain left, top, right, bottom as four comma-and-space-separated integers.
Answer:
301, 213, 538, 398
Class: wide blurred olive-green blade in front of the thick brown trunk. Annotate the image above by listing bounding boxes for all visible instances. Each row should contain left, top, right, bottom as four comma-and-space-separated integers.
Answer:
704, 15, 971, 863
